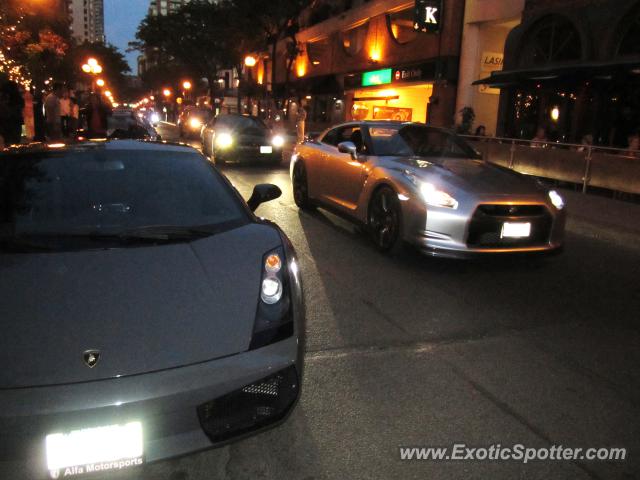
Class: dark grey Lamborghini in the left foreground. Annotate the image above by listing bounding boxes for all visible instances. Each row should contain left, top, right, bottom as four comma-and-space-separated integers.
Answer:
0, 140, 304, 478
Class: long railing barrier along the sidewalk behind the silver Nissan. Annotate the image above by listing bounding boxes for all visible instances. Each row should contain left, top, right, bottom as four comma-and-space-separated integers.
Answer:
464, 135, 640, 194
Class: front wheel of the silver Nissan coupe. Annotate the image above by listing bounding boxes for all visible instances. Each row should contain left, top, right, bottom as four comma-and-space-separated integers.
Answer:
367, 187, 402, 253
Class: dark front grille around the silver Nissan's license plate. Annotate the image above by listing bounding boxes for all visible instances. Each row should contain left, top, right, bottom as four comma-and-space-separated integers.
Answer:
467, 205, 553, 249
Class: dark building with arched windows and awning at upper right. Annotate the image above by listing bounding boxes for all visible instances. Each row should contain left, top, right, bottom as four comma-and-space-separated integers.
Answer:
478, 0, 640, 147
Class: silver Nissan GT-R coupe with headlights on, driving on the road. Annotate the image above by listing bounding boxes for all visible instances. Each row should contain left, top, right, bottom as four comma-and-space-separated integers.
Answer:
291, 121, 565, 258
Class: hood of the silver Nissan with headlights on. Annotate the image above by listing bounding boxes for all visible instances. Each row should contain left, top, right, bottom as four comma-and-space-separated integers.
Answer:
402, 158, 541, 195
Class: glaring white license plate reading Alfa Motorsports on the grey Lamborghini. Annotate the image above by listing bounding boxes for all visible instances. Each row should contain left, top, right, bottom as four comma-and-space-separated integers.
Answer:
46, 422, 144, 479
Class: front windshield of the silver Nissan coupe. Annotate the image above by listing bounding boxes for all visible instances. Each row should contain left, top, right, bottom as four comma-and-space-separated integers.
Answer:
369, 125, 478, 159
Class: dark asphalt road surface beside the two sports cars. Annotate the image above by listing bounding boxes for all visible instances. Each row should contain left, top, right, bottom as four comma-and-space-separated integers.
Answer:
92, 125, 640, 480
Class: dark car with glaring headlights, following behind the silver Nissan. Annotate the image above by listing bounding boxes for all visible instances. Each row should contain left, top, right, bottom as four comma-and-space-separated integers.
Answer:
202, 114, 285, 165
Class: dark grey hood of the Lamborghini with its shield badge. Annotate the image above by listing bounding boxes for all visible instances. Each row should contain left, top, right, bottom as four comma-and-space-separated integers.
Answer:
0, 224, 281, 389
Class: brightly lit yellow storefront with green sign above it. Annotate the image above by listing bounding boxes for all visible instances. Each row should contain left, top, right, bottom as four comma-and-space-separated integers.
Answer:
345, 58, 457, 123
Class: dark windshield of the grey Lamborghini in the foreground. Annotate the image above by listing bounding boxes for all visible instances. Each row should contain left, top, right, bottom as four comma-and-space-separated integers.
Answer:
0, 149, 249, 252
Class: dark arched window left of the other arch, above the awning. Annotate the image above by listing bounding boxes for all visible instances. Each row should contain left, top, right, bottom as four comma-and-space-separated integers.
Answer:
521, 15, 582, 66
